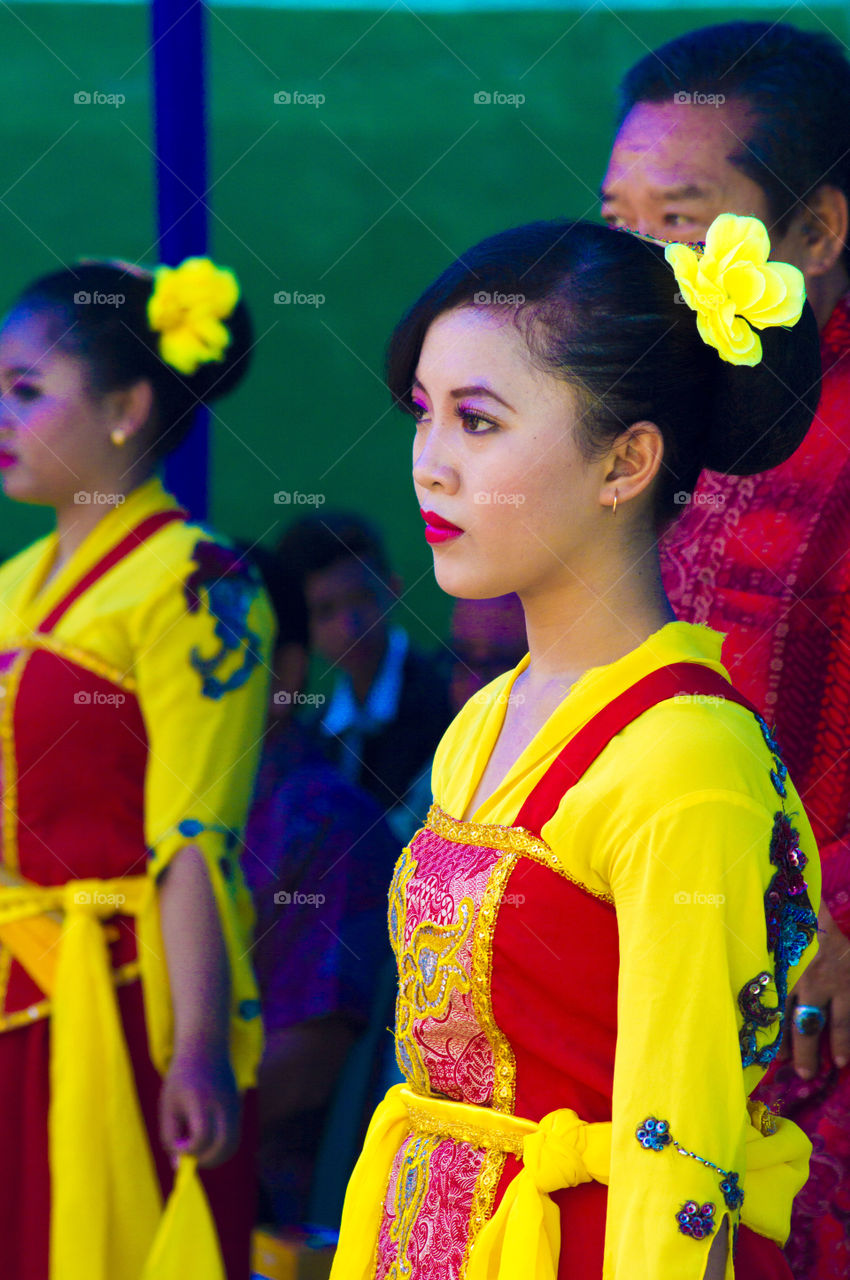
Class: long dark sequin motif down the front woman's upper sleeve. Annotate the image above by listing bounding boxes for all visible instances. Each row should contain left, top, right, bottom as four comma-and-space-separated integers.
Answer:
737, 716, 818, 1066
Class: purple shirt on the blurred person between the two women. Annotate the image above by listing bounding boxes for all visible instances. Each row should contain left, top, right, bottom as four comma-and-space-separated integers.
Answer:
243, 722, 399, 1030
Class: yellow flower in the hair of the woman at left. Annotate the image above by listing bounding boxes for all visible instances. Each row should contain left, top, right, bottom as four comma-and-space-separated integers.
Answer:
147, 257, 239, 374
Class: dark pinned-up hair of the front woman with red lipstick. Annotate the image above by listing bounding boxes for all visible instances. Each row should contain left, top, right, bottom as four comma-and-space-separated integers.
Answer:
387, 219, 821, 526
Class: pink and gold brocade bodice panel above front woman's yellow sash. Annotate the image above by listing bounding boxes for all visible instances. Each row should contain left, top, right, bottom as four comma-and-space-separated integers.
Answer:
389, 828, 499, 1106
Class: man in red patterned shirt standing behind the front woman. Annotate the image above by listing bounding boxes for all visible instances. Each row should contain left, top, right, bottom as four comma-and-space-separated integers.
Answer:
602, 22, 850, 1280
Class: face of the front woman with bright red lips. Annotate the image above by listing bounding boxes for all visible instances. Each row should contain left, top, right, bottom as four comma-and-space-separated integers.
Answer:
412, 307, 611, 599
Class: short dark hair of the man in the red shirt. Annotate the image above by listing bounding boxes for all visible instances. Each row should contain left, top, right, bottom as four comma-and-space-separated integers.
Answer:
617, 22, 850, 261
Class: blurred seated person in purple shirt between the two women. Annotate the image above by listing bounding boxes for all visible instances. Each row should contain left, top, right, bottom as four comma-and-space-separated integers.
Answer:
243, 548, 398, 1228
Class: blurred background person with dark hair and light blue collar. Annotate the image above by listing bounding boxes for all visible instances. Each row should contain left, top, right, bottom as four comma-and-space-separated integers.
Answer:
278, 511, 451, 810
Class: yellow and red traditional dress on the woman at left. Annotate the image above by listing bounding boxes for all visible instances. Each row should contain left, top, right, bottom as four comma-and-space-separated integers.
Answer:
0, 477, 273, 1280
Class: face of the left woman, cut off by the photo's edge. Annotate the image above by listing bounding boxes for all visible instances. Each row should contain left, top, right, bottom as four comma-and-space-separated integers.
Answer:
0, 310, 115, 507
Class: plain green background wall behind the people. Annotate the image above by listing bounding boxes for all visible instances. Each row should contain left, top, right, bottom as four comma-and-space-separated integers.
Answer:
0, 4, 847, 644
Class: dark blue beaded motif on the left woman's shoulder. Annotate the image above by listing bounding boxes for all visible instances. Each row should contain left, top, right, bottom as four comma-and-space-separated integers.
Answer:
183, 539, 262, 699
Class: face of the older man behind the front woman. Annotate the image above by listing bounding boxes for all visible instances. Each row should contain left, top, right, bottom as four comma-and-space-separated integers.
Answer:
602, 100, 801, 265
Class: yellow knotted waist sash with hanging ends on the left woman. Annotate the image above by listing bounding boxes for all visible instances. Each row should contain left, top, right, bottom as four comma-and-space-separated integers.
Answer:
0, 876, 221, 1280
